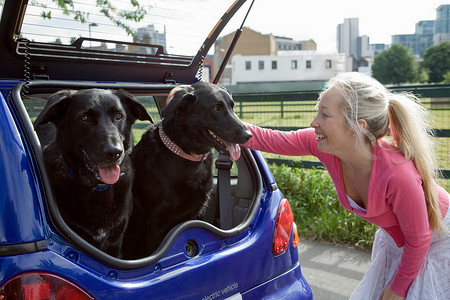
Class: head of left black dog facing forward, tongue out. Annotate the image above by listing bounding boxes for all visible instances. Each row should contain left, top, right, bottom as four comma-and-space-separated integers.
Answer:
34, 89, 153, 184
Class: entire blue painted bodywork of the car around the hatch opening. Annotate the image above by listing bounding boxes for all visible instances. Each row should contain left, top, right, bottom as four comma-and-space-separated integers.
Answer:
0, 85, 312, 300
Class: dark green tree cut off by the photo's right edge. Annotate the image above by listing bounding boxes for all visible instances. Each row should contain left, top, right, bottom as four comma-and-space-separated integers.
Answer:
421, 41, 450, 82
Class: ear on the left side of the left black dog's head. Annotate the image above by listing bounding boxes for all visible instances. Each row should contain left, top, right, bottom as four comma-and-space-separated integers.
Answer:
34, 90, 77, 129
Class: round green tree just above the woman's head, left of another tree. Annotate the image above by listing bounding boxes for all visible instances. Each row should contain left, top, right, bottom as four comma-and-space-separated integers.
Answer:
372, 44, 418, 85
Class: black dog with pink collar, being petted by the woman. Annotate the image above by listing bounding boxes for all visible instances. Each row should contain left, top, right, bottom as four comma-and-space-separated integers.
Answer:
124, 82, 251, 259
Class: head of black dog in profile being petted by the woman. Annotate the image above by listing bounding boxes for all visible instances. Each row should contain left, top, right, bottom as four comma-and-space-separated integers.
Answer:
162, 82, 252, 160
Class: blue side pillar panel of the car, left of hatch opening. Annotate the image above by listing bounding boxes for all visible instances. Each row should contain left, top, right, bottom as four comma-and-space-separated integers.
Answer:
0, 94, 45, 245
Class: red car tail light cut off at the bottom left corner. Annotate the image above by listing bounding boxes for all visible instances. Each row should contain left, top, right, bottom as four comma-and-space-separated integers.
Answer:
0, 273, 94, 300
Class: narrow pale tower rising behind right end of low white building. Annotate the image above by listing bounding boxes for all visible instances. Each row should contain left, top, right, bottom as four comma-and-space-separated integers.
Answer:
336, 18, 359, 57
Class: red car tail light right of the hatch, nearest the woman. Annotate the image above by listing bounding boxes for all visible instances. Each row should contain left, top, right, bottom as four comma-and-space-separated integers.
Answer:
272, 199, 298, 255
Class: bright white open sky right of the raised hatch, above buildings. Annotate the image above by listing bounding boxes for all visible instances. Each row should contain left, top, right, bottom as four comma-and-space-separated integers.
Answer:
232, 0, 450, 51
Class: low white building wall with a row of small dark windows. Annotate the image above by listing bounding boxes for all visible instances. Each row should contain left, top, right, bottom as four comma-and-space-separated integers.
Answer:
231, 51, 345, 85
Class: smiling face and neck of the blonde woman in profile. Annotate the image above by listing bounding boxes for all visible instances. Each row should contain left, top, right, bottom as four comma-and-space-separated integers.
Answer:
311, 88, 356, 157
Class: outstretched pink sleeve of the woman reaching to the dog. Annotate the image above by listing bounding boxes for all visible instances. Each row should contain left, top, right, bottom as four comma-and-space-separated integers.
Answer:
242, 123, 318, 156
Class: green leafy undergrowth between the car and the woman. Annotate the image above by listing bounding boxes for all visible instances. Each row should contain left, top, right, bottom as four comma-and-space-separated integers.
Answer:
270, 164, 378, 250
